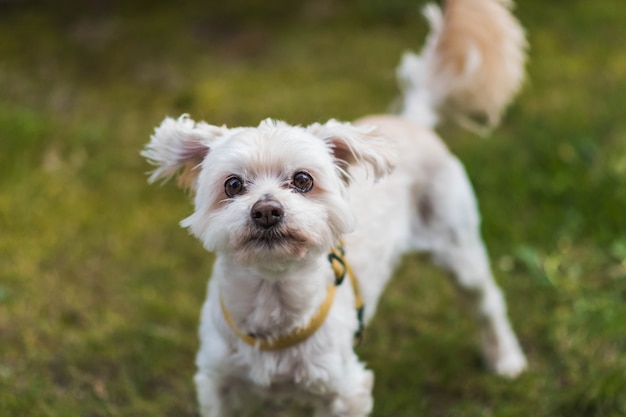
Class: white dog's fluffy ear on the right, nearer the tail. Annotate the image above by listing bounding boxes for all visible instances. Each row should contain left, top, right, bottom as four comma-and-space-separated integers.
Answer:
307, 119, 397, 179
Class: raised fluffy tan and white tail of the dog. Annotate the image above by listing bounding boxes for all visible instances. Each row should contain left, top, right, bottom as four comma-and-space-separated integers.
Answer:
397, 0, 527, 133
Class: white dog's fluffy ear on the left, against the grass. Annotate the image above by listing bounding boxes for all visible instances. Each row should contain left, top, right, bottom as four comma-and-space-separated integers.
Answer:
141, 115, 228, 189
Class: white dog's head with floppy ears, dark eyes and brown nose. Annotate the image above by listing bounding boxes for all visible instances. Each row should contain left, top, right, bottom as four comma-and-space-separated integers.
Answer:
142, 116, 394, 264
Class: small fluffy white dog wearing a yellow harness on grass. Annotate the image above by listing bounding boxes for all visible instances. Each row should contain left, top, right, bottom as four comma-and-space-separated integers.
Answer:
143, 0, 526, 417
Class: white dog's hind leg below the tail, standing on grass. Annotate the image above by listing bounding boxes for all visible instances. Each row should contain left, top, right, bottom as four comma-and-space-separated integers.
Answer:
416, 158, 526, 377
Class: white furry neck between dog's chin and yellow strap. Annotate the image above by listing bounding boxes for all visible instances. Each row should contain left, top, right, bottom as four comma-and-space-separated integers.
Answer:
214, 255, 333, 339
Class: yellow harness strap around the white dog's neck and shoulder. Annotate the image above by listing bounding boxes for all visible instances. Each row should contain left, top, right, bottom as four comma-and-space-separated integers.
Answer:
220, 242, 363, 350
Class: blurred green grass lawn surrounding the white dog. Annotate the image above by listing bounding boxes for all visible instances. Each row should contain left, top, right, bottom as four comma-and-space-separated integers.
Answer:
0, 0, 626, 417
